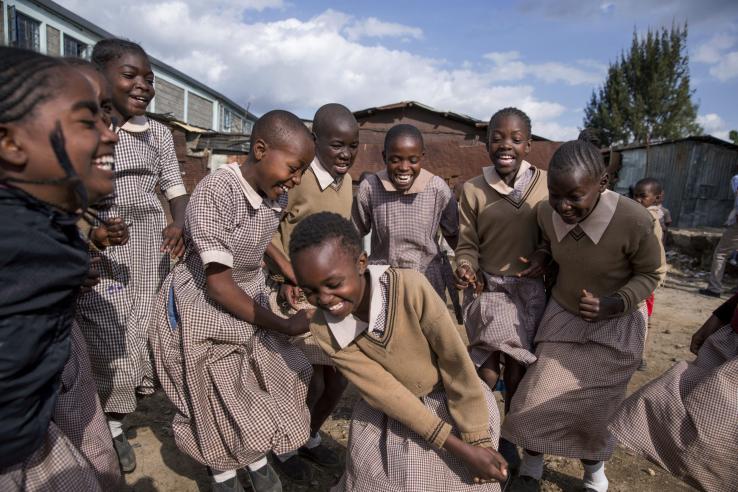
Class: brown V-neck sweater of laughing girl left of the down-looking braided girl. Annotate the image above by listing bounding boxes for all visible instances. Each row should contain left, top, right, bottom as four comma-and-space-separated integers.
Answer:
456, 169, 548, 276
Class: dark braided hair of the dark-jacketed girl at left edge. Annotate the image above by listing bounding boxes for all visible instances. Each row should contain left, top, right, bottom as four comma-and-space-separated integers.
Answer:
0, 46, 64, 123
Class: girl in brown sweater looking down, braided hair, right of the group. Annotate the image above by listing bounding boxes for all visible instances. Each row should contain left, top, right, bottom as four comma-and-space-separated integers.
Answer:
502, 141, 665, 492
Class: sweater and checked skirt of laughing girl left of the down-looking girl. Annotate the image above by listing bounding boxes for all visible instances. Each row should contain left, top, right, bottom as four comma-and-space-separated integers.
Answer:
456, 161, 548, 366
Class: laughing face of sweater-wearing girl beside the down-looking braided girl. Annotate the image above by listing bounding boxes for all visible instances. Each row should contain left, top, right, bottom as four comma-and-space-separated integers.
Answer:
487, 115, 530, 177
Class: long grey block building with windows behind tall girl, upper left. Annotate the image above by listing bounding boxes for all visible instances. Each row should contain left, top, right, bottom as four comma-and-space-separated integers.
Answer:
0, 0, 256, 134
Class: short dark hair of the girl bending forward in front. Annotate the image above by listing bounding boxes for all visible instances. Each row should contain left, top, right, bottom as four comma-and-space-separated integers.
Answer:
290, 212, 363, 261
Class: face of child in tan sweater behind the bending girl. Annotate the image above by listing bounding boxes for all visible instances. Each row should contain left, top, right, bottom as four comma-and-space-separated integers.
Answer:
315, 118, 359, 179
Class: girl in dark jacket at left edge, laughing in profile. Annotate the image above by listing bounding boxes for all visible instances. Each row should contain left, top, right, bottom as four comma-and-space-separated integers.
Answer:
0, 47, 114, 491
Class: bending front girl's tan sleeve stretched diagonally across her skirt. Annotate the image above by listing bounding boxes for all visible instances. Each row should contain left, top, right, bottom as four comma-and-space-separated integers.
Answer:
310, 320, 451, 448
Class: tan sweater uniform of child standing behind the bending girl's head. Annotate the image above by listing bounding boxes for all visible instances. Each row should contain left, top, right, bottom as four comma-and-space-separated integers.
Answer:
269, 157, 354, 366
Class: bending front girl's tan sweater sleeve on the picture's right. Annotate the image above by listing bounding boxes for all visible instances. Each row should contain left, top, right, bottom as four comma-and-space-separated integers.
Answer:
406, 275, 494, 447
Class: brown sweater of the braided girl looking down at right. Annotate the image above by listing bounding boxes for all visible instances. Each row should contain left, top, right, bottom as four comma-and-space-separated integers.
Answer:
538, 192, 666, 315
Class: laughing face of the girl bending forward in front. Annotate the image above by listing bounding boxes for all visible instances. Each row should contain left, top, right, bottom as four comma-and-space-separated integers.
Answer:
292, 238, 368, 319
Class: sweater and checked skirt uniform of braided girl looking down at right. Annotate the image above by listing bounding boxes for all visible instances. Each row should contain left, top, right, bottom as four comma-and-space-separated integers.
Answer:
502, 191, 666, 461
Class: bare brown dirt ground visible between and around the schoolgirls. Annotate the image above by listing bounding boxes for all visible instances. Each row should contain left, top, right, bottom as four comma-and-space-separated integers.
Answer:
119, 256, 724, 492
